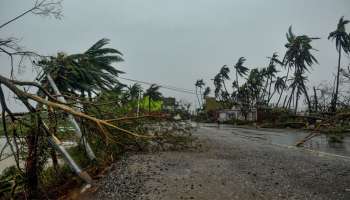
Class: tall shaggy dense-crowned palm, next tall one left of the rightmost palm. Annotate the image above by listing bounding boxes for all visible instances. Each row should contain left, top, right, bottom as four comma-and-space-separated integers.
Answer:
284, 26, 319, 111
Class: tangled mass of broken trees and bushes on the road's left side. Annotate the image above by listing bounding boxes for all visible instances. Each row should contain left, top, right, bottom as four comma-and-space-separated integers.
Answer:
0, 0, 193, 199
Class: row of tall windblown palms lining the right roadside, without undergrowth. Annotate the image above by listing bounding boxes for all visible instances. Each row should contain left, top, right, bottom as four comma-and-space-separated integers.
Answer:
195, 17, 350, 113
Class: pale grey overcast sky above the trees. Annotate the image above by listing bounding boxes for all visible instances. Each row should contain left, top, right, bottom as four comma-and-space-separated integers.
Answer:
0, 0, 350, 109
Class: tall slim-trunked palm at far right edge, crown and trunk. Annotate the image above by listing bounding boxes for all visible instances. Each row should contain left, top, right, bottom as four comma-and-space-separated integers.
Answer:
328, 17, 350, 112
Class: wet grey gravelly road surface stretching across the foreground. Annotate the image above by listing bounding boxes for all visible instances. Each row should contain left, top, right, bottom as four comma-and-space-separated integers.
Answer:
88, 124, 350, 200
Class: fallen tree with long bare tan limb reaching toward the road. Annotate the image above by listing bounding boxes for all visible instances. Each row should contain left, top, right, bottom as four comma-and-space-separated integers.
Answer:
0, 75, 194, 196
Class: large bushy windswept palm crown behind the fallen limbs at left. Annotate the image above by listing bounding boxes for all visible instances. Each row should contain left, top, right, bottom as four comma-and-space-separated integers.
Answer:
37, 39, 123, 96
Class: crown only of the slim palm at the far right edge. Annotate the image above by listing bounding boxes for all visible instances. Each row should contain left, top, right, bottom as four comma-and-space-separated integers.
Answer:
328, 17, 350, 53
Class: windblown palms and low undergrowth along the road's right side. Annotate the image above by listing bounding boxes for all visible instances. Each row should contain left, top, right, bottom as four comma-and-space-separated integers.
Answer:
195, 17, 350, 142
